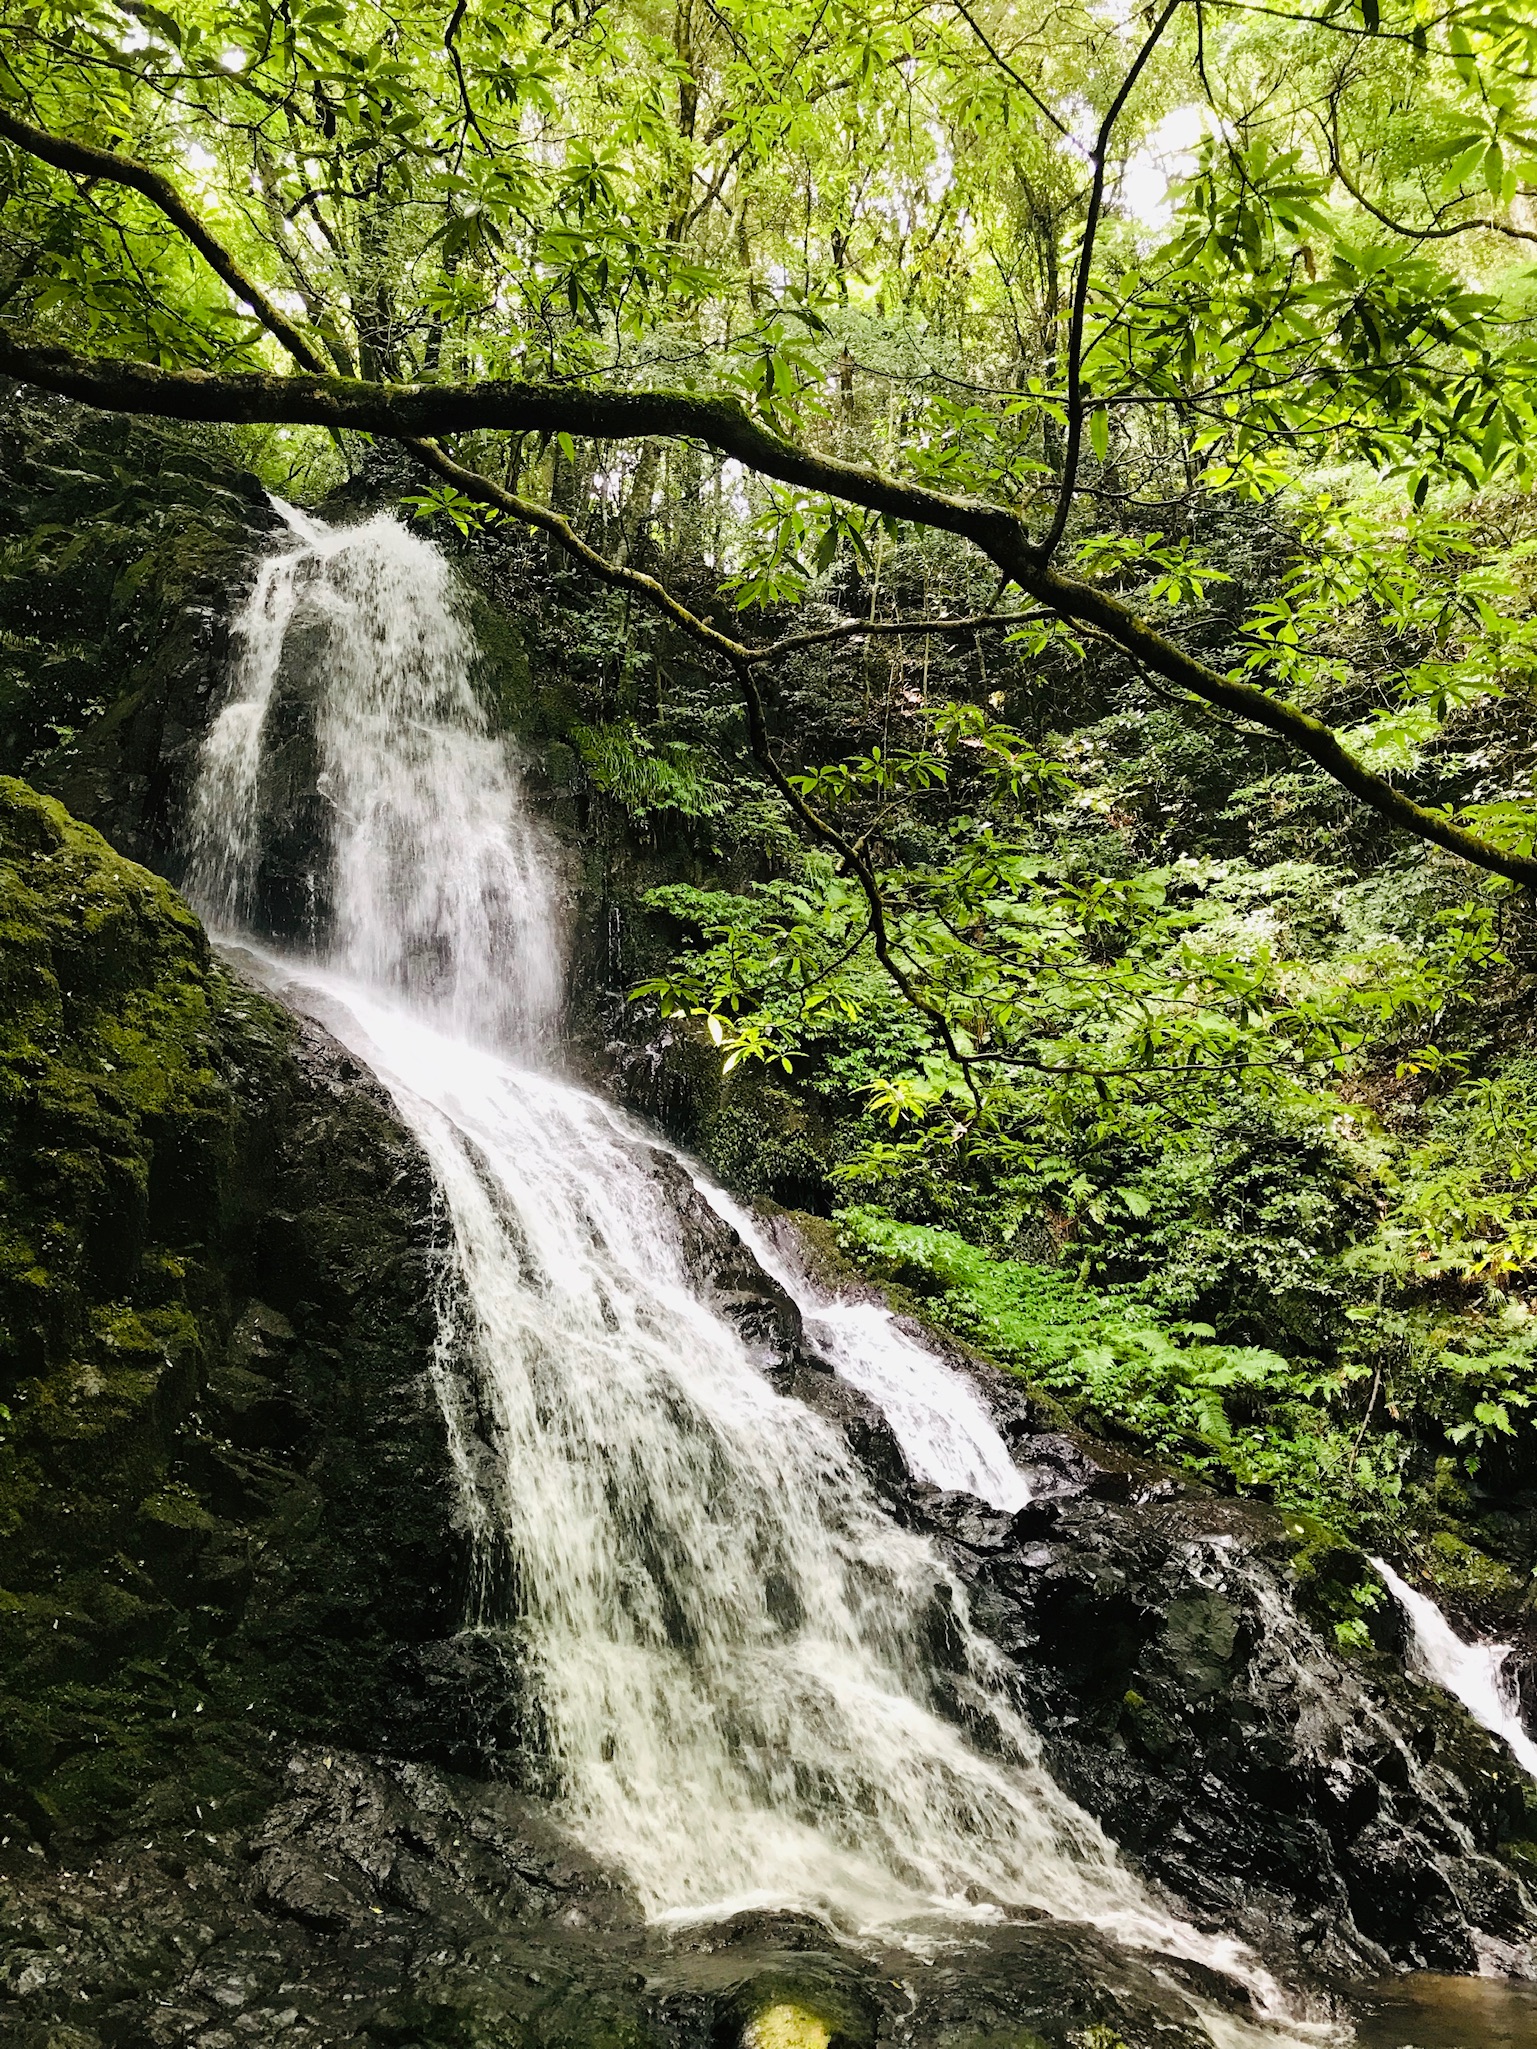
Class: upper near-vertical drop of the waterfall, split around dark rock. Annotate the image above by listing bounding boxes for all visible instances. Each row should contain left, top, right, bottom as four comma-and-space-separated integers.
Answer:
189, 493, 564, 1051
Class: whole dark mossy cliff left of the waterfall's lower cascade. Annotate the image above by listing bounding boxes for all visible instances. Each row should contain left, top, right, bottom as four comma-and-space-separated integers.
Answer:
0, 779, 475, 1865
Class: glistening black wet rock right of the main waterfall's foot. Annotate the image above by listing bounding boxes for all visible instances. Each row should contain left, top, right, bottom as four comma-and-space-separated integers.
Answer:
914, 1490, 1533, 1971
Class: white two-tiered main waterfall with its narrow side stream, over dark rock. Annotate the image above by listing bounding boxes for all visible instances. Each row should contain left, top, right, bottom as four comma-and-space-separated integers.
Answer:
193, 514, 1336, 2043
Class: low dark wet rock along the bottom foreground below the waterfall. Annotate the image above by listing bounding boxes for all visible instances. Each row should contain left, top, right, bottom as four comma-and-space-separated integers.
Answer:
0, 1746, 1270, 2049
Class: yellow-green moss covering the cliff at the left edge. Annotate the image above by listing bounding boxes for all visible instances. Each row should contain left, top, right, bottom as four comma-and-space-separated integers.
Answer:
0, 779, 232, 1584
